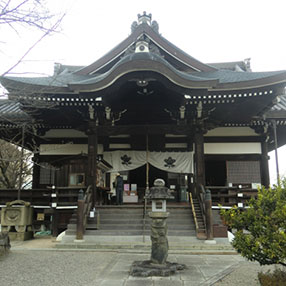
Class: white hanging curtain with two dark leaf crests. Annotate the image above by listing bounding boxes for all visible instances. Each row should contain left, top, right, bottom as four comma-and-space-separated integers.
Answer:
103, 151, 193, 174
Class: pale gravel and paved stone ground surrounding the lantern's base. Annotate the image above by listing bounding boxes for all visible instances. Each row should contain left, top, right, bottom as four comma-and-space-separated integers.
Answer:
0, 240, 278, 286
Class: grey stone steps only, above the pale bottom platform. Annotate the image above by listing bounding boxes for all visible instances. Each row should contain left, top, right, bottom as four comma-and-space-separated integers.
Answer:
63, 204, 204, 239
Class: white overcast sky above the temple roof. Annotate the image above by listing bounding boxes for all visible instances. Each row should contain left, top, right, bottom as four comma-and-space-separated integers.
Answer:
0, 0, 286, 183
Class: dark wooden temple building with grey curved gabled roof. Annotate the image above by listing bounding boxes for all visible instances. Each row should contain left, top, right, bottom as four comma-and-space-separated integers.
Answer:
0, 12, 286, 239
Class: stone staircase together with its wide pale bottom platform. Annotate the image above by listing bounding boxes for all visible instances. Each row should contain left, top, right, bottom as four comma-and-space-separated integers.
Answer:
56, 200, 235, 251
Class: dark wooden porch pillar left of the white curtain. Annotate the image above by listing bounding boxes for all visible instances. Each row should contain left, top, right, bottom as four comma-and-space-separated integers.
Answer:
87, 127, 98, 205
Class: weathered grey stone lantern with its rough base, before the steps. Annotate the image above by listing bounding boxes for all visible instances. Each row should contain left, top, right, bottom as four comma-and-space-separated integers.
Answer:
130, 179, 186, 277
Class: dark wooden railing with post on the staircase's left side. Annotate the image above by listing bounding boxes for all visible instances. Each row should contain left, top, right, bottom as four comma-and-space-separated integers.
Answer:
76, 186, 92, 240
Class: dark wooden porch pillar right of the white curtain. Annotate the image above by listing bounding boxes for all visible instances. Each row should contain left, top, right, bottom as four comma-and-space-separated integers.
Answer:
195, 128, 205, 190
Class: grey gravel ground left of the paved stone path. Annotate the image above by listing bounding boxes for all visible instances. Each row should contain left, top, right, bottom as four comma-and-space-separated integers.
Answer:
0, 250, 118, 286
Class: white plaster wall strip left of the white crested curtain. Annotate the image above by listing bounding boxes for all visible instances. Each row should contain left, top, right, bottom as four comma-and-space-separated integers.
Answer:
40, 144, 103, 155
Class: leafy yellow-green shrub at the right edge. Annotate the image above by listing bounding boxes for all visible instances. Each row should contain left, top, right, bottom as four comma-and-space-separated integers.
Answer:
221, 178, 286, 268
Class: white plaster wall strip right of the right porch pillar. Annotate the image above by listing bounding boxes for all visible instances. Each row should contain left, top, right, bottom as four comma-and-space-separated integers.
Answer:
204, 142, 261, 154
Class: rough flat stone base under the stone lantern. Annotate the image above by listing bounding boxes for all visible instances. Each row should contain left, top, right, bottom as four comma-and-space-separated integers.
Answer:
130, 260, 186, 277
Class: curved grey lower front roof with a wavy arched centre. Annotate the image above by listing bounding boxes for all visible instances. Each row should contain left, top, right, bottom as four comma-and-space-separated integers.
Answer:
0, 53, 286, 92
